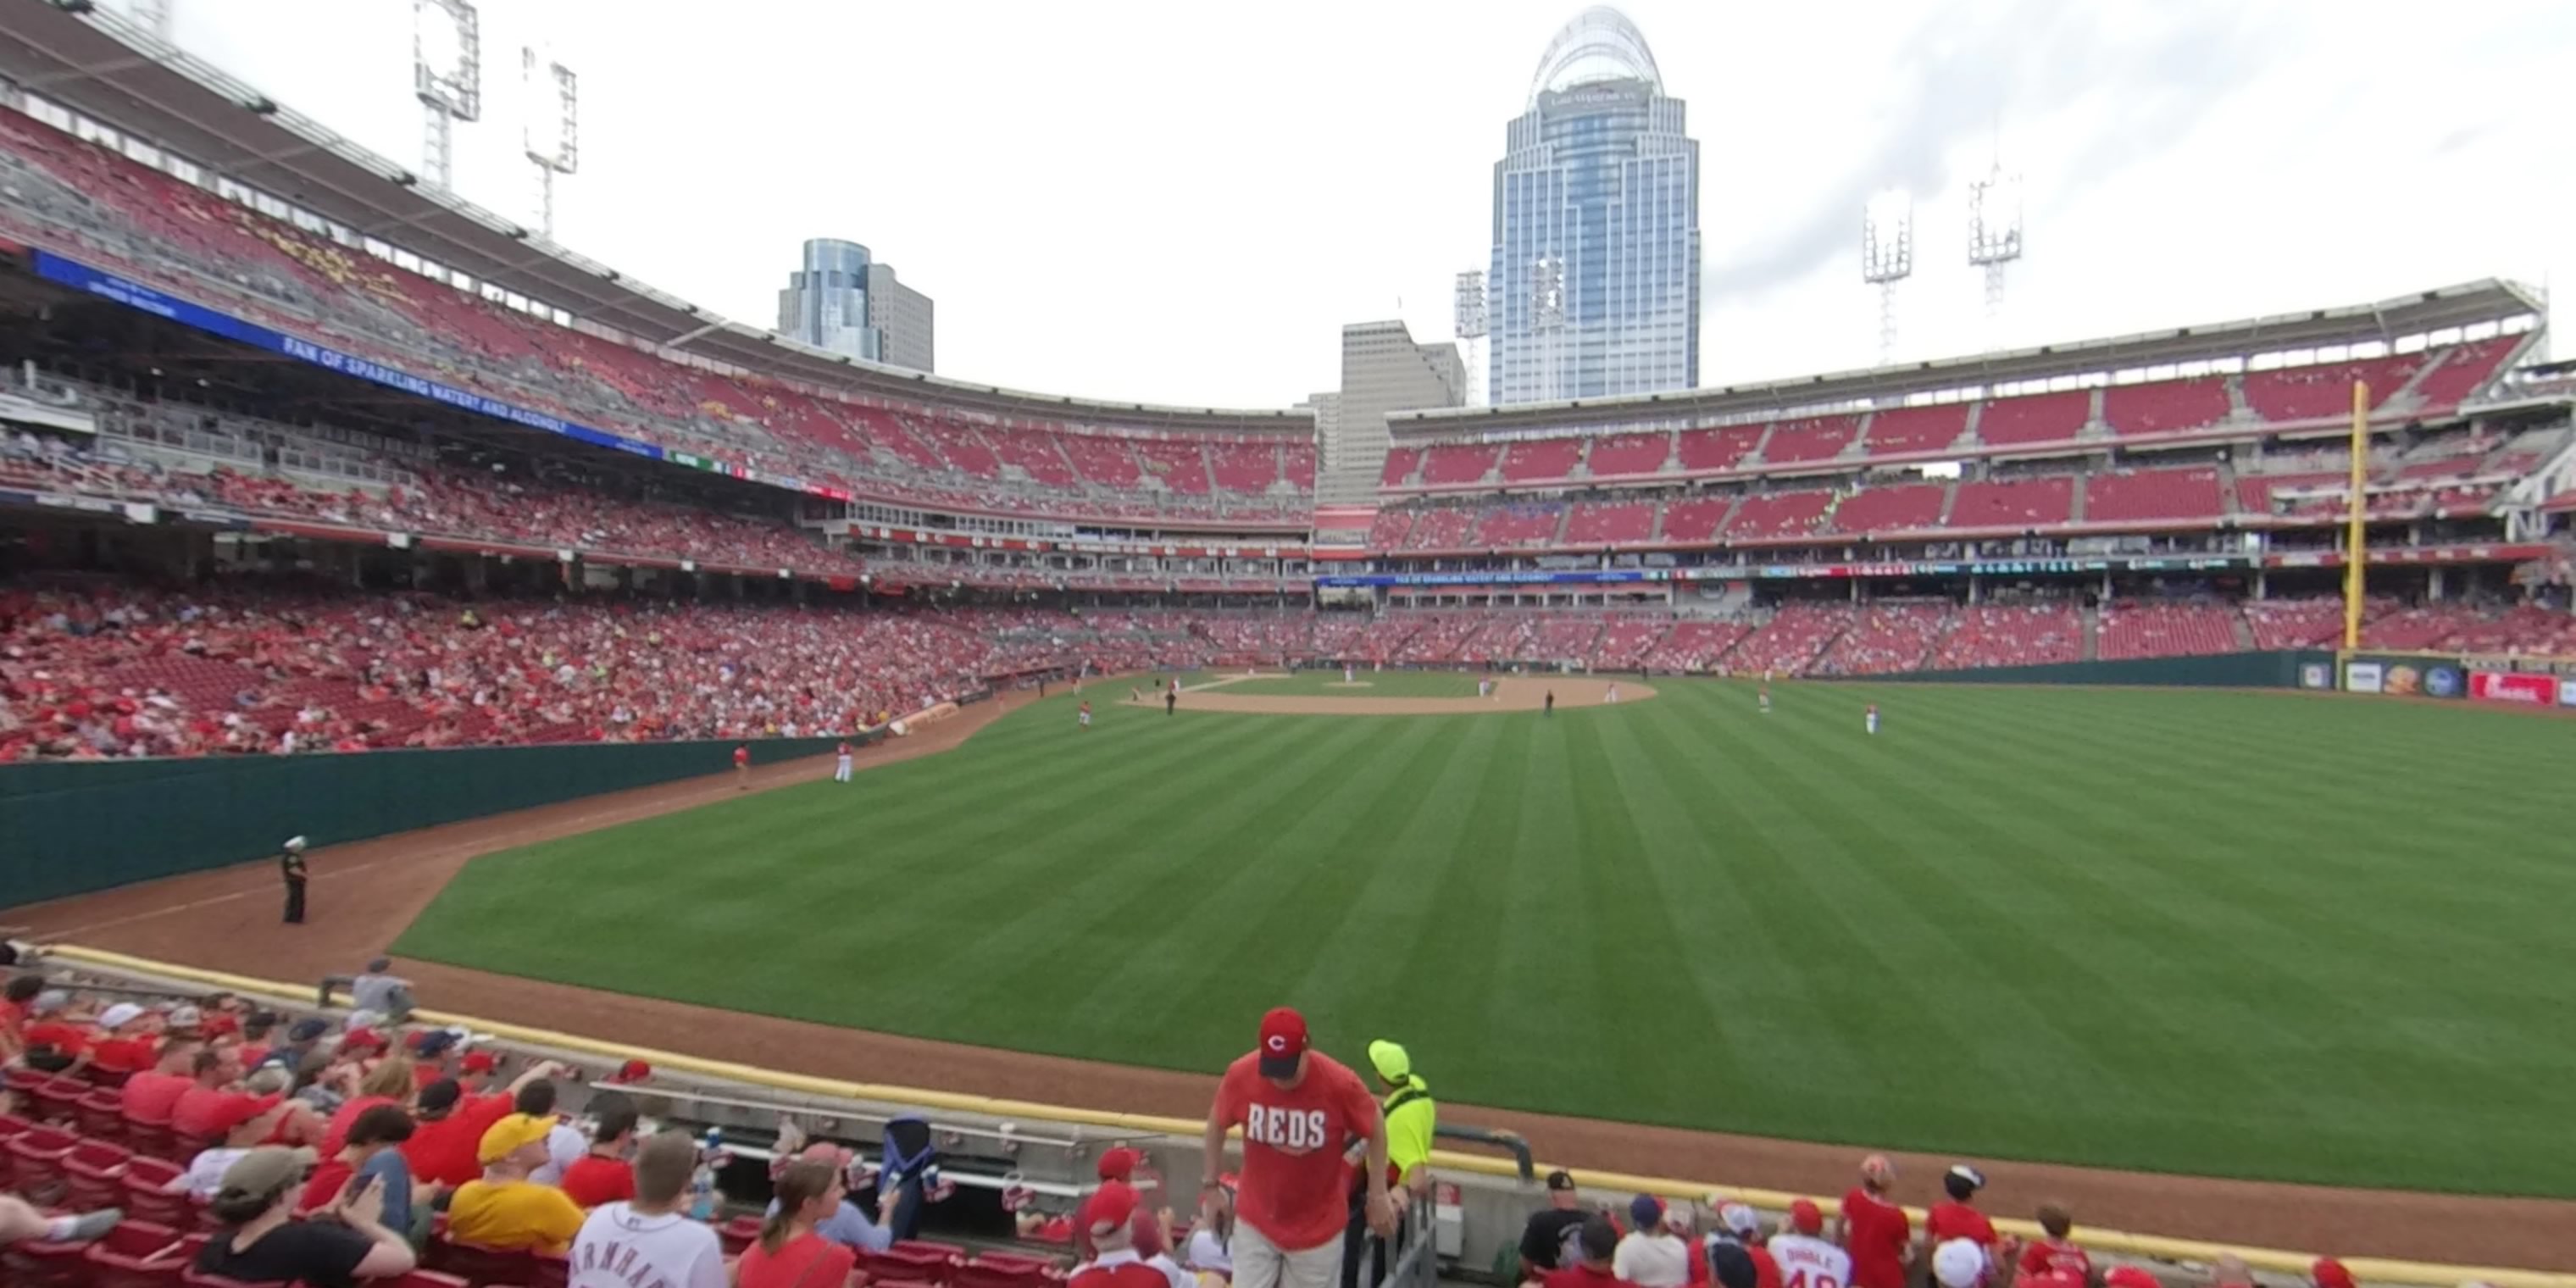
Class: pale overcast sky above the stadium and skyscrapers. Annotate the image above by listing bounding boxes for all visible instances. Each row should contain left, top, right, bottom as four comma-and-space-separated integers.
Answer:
146, 0, 2576, 407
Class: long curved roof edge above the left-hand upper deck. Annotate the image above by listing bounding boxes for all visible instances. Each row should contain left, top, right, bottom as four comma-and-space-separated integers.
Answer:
0, 0, 1313, 433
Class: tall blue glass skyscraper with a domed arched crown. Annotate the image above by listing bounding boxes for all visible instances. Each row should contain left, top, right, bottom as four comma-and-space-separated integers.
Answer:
1486, 8, 1700, 404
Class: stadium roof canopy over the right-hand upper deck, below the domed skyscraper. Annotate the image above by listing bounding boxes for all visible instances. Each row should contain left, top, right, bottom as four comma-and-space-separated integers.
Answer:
1386, 278, 2548, 438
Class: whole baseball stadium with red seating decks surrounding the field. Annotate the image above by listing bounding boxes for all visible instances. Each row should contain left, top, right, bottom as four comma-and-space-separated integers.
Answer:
0, 0, 2576, 1288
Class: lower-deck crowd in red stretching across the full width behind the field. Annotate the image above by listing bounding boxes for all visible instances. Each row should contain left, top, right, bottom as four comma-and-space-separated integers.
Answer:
0, 580, 2576, 763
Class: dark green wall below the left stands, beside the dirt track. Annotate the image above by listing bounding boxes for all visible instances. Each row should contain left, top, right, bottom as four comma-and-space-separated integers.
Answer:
0, 729, 886, 907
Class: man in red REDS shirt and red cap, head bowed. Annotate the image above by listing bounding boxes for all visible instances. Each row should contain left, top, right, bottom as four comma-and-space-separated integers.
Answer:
1198, 1008, 1396, 1288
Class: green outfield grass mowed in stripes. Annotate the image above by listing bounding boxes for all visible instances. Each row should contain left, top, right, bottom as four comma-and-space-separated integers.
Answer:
399, 680, 2576, 1198
